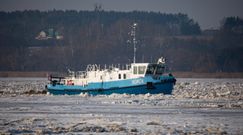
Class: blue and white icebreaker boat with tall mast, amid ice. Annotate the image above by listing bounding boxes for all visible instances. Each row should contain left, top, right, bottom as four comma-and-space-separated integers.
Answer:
46, 23, 176, 95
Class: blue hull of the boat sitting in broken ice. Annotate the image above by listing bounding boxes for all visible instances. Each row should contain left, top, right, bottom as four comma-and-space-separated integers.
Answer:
47, 76, 175, 95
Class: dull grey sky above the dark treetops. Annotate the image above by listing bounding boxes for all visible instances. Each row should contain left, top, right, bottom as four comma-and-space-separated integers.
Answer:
0, 0, 243, 29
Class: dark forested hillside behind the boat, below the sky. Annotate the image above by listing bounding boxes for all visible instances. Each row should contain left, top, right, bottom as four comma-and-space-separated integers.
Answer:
0, 10, 243, 72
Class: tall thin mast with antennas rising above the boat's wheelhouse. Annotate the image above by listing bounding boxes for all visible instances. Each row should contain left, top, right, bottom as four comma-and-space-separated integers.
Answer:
128, 23, 137, 63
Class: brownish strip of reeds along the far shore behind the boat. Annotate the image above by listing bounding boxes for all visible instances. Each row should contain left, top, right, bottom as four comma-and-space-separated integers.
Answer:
0, 71, 243, 78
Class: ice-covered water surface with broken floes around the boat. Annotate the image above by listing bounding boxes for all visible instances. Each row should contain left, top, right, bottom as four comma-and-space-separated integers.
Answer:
0, 78, 243, 135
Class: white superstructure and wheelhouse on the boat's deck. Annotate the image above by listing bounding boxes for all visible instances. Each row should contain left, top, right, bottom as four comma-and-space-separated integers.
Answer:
63, 63, 149, 85
